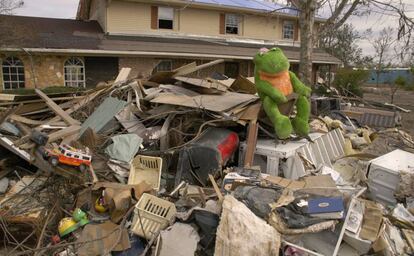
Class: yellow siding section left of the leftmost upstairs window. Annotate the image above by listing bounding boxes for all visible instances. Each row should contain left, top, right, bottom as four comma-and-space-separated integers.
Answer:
107, 1, 151, 34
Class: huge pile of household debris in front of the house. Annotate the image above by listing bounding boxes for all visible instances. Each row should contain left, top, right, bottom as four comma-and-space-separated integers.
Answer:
0, 61, 414, 256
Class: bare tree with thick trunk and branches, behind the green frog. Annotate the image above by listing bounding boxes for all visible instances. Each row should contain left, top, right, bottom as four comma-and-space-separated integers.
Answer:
269, 0, 414, 85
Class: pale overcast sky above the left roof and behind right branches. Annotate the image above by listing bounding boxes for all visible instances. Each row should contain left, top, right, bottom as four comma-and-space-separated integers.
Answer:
15, 0, 414, 54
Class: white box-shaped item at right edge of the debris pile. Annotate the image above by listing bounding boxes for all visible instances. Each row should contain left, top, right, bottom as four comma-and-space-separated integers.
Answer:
368, 149, 414, 205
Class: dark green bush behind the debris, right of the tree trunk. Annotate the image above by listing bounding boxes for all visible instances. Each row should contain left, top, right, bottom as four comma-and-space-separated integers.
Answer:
333, 68, 369, 97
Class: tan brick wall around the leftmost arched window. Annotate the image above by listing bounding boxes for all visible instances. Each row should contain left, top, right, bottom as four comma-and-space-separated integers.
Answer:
0, 54, 67, 90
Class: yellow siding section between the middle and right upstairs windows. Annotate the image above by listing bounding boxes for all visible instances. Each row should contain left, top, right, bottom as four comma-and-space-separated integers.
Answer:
244, 15, 282, 40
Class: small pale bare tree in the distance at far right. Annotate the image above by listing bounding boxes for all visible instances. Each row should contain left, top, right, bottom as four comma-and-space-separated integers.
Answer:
371, 27, 396, 88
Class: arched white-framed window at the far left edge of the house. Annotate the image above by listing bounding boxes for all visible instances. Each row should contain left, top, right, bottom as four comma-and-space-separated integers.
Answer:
2, 57, 25, 90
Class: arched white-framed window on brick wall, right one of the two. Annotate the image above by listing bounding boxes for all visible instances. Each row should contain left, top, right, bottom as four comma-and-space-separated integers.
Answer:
63, 57, 85, 87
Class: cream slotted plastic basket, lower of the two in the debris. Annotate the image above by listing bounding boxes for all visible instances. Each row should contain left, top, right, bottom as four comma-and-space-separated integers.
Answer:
131, 193, 177, 239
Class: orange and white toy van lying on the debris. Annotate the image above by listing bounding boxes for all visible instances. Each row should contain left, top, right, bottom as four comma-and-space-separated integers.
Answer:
45, 144, 92, 172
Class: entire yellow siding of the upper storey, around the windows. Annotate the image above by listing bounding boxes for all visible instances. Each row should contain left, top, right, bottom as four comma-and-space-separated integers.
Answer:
105, 0, 300, 41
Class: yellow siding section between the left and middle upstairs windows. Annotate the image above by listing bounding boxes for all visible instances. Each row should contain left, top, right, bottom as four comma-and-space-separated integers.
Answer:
179, 8, 220, 36
